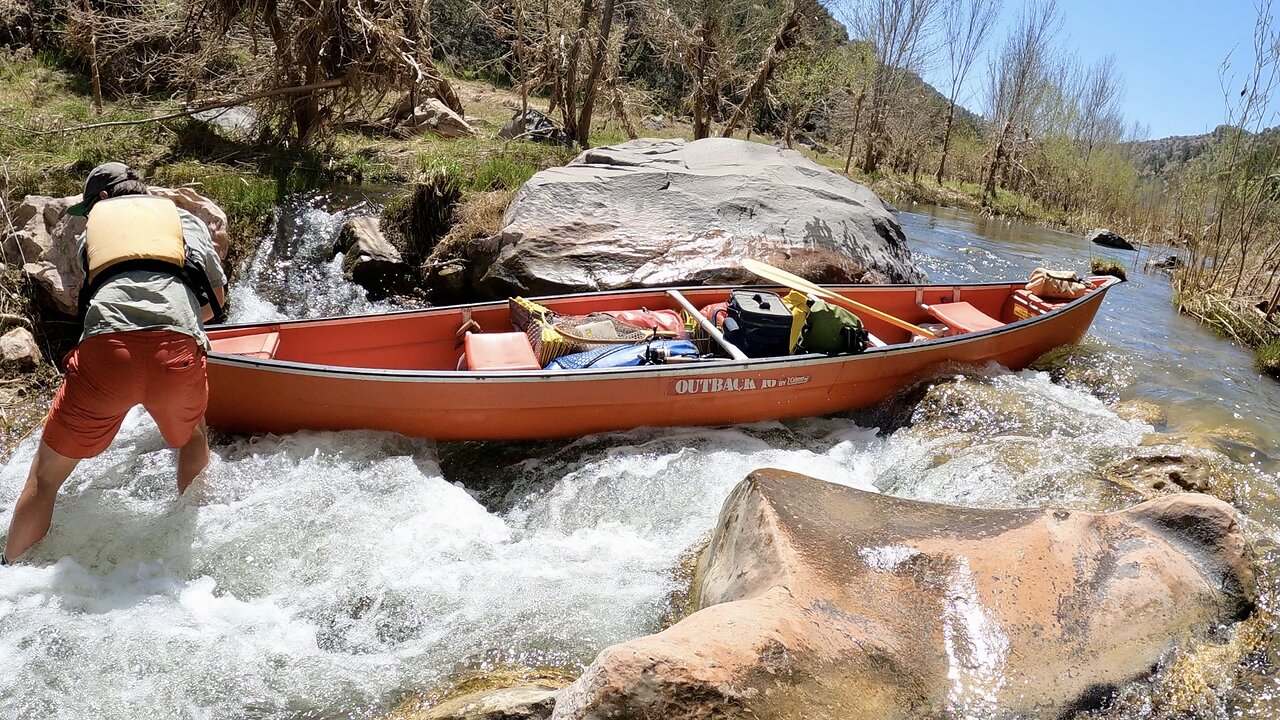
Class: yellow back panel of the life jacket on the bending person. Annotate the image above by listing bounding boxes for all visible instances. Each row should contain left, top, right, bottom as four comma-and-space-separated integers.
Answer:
84, 195, 187, 284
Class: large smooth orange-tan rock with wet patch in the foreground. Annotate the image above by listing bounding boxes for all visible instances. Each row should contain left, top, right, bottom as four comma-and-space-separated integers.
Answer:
553, 470, 1253, 720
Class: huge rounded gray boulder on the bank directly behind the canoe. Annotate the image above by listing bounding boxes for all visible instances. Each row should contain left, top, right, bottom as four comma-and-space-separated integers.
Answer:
468, 138, 924, 297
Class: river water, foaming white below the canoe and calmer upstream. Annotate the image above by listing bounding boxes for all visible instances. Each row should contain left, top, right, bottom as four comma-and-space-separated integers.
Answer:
0, 196, 1280, 719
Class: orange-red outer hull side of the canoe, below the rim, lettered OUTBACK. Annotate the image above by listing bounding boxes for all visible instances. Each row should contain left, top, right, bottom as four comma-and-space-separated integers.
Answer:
207, 279, 1107, 441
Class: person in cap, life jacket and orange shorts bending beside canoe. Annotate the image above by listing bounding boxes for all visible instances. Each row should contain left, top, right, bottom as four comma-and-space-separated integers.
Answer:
0, 163, 227, 564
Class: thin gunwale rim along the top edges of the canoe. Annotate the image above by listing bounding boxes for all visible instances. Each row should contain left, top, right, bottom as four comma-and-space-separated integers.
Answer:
209, 278, 1119, 383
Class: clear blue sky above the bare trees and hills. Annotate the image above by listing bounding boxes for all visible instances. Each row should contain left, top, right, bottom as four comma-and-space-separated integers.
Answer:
924, 0, 1259, 138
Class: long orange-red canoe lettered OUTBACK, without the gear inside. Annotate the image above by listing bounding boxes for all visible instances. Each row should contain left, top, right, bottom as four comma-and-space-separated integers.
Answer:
207, 278, 1116, 439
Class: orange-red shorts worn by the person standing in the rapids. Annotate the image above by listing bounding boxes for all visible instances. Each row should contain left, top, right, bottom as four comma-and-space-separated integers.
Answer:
44, 331, 209, 459
